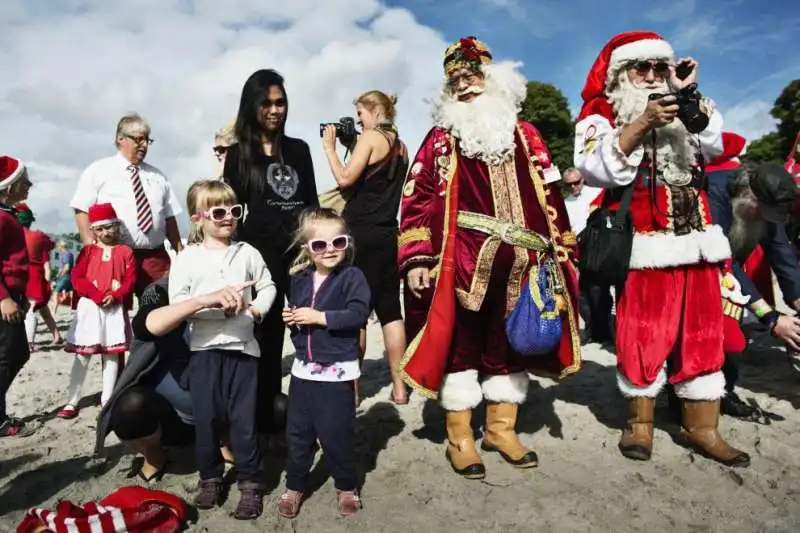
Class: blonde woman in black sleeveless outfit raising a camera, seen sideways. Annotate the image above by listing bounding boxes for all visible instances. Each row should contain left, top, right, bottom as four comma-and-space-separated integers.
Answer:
322, 91, 408, 405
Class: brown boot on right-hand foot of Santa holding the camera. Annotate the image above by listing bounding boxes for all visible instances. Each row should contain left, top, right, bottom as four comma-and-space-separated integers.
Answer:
681, 400, 750, 467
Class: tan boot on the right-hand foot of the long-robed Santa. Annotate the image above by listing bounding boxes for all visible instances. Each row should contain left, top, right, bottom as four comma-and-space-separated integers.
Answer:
481, 403, 539, 468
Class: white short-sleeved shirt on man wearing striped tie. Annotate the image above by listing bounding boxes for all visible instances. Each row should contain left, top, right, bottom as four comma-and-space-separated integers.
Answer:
69, 153, 183, 250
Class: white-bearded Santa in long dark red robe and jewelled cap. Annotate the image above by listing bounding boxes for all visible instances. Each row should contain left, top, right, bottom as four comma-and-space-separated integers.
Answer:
399, 37, 580, 479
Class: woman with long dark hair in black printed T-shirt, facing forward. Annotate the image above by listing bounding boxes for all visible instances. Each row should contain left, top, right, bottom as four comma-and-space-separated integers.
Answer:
223, 70, 319, 433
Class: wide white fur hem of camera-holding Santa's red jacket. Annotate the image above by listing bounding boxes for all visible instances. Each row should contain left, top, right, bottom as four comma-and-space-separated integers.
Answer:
630, 225, 731, 269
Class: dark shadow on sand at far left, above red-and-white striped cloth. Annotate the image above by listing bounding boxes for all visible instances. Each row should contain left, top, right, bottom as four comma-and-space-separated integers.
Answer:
0, 444, 125, 516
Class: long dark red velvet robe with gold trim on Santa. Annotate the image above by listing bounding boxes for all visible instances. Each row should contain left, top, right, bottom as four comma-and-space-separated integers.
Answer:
399, 122, 581, 398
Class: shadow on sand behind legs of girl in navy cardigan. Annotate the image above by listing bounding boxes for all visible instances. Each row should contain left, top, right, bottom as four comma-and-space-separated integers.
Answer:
307, 402, 406, 497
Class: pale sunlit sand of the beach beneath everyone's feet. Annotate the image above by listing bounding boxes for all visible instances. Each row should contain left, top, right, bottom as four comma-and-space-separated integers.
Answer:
0, 310, 800, 533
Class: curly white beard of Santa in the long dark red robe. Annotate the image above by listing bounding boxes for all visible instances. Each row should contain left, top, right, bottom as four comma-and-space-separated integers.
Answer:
433, 62, 527, 165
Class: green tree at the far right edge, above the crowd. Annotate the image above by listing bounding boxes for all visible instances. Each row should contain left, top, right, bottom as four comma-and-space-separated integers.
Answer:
744, 79, 800, 162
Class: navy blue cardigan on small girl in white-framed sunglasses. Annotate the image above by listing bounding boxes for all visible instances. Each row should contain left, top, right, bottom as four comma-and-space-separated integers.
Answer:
289, 266, 371, 364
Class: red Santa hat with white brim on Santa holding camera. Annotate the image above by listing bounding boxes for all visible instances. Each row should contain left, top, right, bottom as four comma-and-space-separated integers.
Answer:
578, 31, 675, 122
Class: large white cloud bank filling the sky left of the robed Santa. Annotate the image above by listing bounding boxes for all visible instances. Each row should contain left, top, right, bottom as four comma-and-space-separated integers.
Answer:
0, 0, 447, 231
